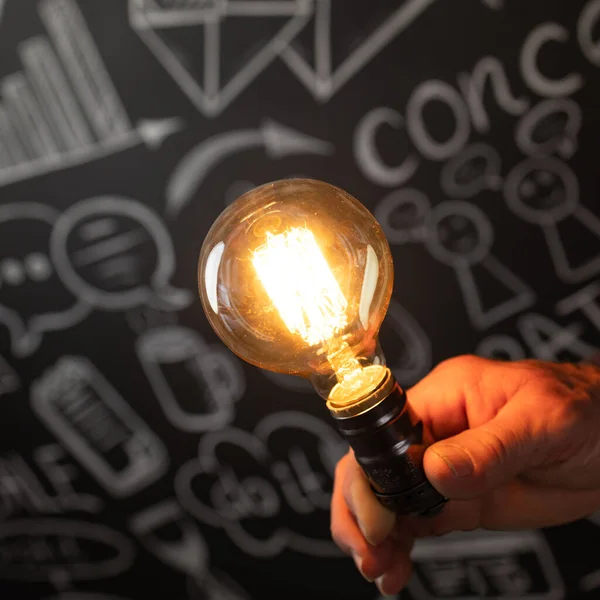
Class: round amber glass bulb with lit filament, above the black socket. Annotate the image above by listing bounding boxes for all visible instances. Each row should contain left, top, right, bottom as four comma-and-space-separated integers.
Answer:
198, 179, 393, 407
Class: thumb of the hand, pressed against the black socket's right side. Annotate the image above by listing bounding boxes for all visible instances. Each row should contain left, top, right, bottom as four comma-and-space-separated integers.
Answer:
424, 414, 538, 500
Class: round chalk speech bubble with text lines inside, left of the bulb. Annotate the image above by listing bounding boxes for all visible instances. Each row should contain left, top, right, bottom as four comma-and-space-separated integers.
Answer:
50, 196, 192, 311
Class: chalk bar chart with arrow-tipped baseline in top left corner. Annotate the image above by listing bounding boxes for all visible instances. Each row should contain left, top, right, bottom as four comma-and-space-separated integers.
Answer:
0, 0, 181, 187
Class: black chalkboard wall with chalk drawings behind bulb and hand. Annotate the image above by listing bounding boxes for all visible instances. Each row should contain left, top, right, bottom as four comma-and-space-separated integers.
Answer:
0, 0, 600, 600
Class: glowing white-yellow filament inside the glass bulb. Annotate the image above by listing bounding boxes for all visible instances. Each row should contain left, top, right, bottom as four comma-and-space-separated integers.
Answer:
252, 227, 348, 346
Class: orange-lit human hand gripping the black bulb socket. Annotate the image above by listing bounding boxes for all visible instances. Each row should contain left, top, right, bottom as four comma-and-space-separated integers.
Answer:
331, 356, 600, 595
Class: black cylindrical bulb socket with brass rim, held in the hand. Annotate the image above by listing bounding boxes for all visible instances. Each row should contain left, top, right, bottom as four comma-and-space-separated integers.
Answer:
328, 370, 447, 517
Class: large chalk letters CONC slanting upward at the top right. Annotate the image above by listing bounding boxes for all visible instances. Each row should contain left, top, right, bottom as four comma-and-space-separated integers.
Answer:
354, 0, 600, 188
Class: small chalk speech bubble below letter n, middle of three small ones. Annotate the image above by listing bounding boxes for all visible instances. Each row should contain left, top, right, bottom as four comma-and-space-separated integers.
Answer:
441, 144, 502, 199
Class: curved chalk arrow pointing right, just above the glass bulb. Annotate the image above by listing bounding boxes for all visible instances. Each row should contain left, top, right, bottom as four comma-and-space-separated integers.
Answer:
166, 120, 333, 217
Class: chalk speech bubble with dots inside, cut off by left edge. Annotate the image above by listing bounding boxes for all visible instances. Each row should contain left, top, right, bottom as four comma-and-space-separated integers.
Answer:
0, 202, 90, 358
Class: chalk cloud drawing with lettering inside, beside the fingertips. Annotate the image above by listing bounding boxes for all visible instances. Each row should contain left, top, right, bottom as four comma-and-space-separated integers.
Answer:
174, 412, 347, 558
